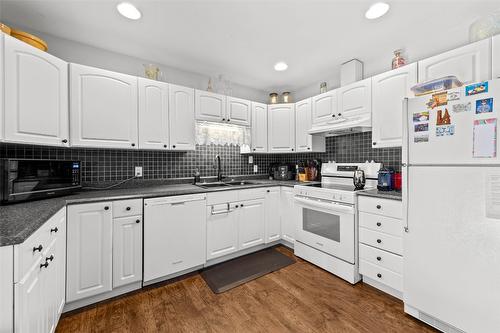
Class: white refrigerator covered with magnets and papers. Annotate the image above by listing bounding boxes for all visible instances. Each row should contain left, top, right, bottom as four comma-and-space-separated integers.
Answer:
403, 80, 500, 333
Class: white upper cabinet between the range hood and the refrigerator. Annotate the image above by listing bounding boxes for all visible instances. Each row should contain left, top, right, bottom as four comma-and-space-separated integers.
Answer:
372, 63, 417, 148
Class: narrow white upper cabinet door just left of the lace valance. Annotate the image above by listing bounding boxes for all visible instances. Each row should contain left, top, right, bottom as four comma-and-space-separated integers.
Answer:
169, 84, 195, 150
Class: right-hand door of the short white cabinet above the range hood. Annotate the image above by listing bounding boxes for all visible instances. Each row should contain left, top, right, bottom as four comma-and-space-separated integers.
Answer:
332, 78, 372, 121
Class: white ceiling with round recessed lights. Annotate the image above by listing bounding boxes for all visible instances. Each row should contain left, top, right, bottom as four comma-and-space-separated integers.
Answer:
1, 0, 500, 91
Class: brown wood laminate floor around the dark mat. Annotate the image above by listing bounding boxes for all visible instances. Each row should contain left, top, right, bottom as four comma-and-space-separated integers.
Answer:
57, 247, 435, 333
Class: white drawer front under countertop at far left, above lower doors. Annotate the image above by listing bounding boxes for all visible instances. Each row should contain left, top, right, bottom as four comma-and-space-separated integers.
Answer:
14, 208, 66, 282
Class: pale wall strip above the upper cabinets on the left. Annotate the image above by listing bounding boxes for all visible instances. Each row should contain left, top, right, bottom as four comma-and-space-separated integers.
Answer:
0, 23, 267, 102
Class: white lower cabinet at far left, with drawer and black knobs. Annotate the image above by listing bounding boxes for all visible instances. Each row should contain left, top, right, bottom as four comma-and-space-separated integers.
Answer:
14, 209, 66, 333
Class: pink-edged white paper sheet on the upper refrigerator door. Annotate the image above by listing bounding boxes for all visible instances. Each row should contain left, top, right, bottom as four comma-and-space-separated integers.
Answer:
472, 118, 497, 158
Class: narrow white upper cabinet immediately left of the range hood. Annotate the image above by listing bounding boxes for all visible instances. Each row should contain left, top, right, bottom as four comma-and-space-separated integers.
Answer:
295, 98, 325, 152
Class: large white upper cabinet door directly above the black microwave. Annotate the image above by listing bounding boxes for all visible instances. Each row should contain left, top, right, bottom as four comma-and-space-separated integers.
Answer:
4, 35, 69, 146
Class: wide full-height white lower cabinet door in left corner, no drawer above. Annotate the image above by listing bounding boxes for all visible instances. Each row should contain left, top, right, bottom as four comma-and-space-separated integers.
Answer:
66, 202, 113, 302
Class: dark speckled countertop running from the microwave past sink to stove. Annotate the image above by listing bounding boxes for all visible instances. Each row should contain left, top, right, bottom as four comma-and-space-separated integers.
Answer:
0, 178, 314, 246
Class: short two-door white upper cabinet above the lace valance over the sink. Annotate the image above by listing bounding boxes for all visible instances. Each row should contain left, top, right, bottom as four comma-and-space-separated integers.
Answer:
195, 90, 251, 126
